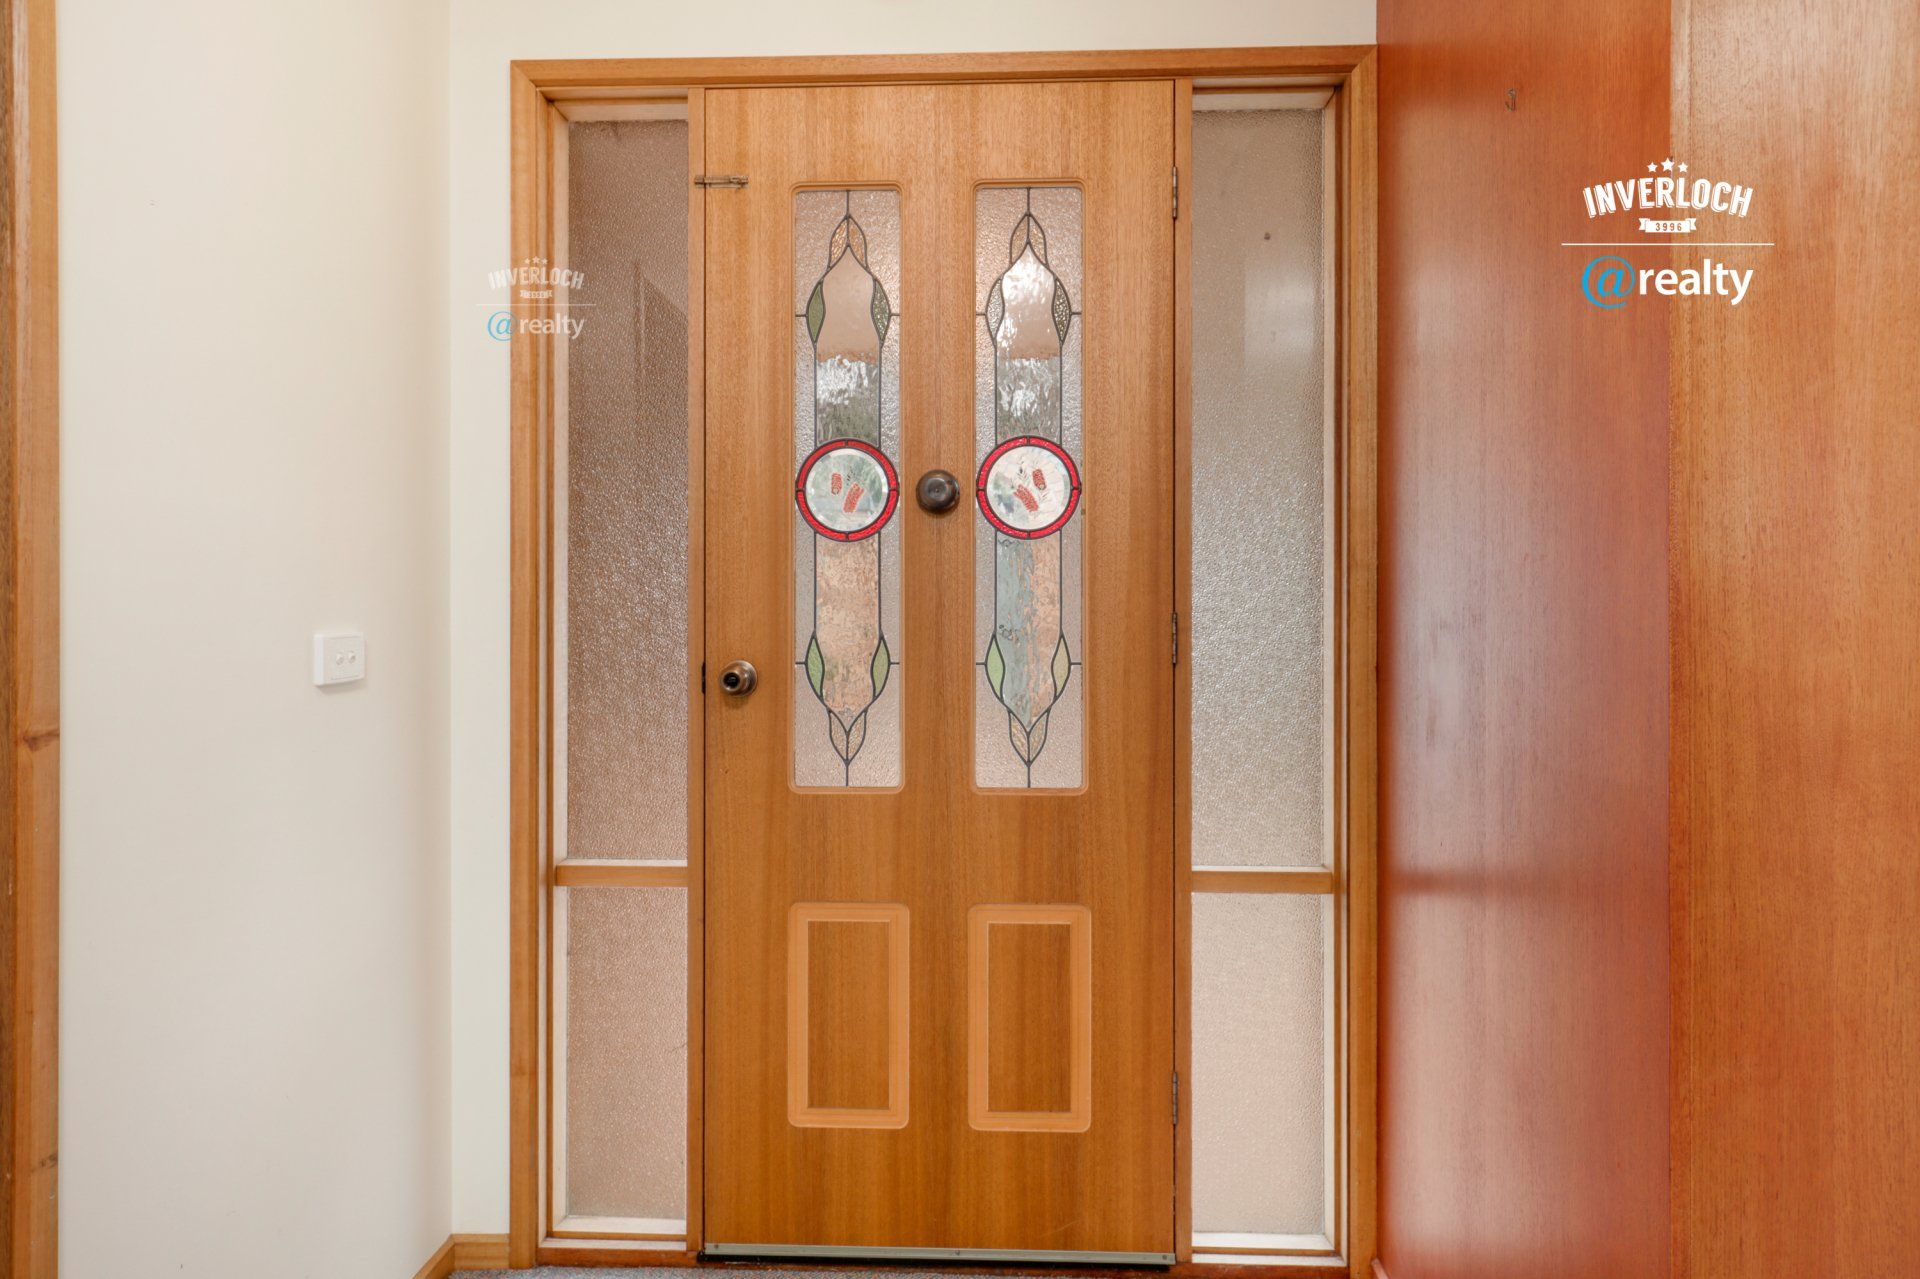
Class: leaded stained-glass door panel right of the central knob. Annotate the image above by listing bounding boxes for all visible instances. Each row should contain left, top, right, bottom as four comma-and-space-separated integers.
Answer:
973, 186, 1085, 789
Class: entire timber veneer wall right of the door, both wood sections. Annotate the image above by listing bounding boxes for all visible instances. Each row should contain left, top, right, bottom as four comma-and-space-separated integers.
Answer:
1380, 0, 1920, 1279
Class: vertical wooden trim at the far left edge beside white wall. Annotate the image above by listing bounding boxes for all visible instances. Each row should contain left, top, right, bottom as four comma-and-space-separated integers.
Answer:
0, 0, 60, 1279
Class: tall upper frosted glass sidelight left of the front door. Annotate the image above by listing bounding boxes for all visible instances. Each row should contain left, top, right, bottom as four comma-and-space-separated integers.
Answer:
563, 121, 689, 860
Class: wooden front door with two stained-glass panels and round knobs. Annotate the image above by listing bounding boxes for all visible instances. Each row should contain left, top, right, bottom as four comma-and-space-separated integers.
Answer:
703, 81, 1175, 1262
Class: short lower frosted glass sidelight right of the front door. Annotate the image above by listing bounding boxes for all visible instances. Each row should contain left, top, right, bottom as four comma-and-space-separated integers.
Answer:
1190, 893, 1332, 1235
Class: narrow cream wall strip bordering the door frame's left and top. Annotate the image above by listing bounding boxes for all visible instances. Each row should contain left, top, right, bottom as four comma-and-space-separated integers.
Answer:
447, 0, 1375, 1233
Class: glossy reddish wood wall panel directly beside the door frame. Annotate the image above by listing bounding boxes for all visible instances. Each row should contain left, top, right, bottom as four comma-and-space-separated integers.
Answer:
1380, 0, 1674, 1279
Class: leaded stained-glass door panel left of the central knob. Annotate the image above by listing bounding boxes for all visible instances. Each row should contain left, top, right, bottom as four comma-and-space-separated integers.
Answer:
793, 190, 900, 785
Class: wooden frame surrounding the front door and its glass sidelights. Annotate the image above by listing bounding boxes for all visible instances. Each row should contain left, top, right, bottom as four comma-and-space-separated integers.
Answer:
507, 46, 1379, 1279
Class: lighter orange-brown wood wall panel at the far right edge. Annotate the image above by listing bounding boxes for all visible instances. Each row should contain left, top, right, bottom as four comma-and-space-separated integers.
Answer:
1672, 0, 1920, 1279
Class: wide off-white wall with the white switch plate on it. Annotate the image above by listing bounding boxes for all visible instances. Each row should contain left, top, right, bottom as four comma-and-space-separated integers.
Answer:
58, 0, 451, 1279
